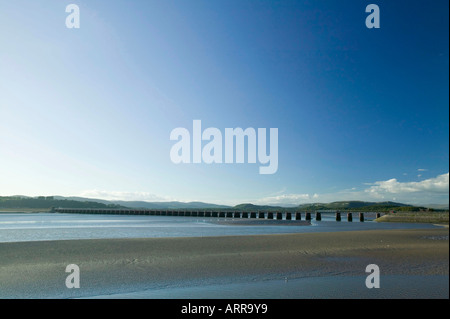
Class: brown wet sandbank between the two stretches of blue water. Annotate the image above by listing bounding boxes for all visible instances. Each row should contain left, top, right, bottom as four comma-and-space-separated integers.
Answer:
0, 228, 449, 298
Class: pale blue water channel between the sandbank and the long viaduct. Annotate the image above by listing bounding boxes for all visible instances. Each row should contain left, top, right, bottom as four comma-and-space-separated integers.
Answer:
0, 213, 442, 242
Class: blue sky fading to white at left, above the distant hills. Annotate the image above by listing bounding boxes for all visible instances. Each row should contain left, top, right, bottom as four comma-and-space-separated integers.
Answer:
0, 0, 449, 205
